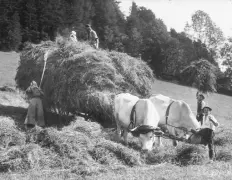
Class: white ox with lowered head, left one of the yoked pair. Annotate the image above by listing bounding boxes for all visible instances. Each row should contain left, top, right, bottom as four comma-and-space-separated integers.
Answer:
114, 93, 160, 150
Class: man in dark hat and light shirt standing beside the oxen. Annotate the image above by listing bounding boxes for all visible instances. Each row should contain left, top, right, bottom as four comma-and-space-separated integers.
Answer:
201, 106, 219, 159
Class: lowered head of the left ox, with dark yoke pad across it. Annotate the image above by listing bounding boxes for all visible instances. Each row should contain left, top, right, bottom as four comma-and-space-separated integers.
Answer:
130, 125, 163, 151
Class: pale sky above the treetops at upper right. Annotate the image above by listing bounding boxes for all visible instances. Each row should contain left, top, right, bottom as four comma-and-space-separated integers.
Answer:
119, 0, 232, 37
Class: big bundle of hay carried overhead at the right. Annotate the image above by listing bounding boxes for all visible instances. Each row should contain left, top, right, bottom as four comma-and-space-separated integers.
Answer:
181, 59, 217, 93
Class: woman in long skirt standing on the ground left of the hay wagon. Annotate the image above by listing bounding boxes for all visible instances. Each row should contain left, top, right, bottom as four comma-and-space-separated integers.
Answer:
24, 81, 45, 130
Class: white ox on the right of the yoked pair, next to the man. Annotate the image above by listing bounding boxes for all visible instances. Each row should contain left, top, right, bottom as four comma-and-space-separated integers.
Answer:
149, 94, 217, 158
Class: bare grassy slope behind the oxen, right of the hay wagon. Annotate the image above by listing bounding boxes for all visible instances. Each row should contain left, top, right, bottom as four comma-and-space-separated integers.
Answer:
153, 81, 232, 127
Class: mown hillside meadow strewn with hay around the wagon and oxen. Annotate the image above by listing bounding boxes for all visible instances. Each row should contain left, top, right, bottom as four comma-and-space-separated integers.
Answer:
0, 53, 232, 180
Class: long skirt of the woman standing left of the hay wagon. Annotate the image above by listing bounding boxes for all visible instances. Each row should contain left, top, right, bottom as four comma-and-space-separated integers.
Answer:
24, 98, 45, 127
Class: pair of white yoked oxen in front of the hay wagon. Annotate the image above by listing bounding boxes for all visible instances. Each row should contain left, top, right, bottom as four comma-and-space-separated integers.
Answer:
114, 93, 213, 158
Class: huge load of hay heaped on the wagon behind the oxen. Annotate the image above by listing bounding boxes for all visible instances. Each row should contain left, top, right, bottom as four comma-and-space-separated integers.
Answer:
15, 37, 154, 120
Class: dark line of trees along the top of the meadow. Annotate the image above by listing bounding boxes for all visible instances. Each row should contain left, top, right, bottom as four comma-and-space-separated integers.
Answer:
0, 0, 232, 94
